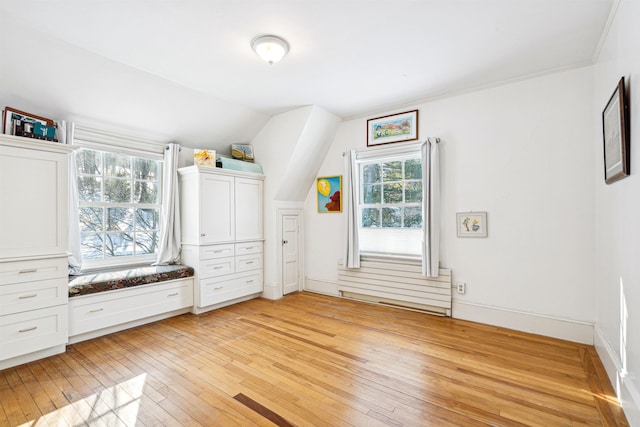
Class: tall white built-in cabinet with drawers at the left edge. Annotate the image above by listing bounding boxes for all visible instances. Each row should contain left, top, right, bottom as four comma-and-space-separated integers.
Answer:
0, 135, 72, 369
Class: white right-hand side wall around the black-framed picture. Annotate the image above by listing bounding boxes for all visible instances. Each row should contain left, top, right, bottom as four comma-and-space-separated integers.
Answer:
592, 0, 640, 425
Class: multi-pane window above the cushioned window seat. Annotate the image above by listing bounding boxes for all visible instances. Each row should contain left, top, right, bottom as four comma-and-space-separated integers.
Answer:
76, 148, 162, 268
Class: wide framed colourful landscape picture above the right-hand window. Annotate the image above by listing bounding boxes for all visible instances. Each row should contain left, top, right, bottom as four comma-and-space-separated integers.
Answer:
367, 110, 418, 147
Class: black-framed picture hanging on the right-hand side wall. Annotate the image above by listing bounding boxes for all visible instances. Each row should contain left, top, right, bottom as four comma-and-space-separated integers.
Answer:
602, 77, 631, 184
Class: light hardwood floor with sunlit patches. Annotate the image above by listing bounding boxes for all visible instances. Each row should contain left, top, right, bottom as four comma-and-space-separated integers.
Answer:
0, 293, 627, 426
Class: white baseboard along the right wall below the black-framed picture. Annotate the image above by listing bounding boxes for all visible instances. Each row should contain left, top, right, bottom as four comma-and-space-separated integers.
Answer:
594, 326, 640, 426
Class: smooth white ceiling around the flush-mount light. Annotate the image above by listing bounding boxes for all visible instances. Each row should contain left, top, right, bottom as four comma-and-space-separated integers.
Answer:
0, 0, 614, 118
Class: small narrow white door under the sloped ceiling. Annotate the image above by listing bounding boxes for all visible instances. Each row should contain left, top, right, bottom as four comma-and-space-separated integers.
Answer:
282, 215, 300, 295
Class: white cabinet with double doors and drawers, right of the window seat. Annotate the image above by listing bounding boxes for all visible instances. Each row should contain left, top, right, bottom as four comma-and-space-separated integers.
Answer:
178, 166, 264, 313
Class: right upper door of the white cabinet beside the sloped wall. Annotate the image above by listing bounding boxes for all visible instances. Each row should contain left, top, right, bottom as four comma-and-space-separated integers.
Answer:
235, 178, 263, 240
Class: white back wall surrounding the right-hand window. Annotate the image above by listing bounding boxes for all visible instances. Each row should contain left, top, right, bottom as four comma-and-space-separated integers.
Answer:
305, 67, 595, 343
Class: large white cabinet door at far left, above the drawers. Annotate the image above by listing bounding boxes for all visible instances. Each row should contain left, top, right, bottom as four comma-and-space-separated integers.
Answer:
0, 147, 68, 258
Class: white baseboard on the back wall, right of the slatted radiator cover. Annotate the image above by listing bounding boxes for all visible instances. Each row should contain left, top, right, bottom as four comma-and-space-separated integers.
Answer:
453, 301, 593, 345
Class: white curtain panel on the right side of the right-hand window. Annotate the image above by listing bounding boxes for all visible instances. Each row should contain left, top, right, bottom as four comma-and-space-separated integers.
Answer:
421, 138, 440, 277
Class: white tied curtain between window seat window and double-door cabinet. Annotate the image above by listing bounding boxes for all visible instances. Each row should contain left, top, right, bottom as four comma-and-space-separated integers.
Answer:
154, 143, 181, 265
